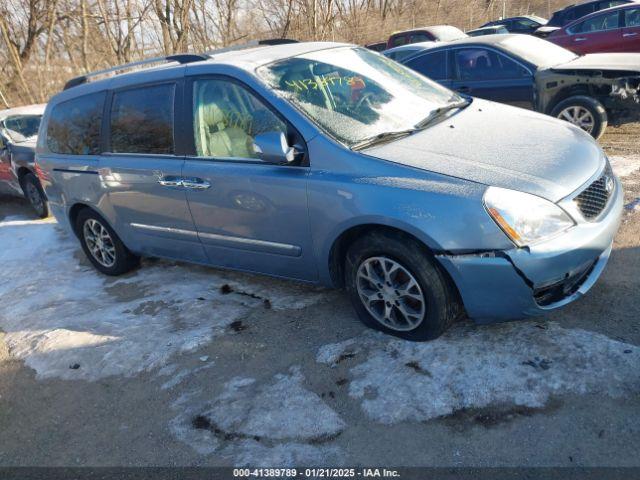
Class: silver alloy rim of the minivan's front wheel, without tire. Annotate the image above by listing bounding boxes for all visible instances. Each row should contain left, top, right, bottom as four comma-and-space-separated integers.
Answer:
356, 257, 426, 332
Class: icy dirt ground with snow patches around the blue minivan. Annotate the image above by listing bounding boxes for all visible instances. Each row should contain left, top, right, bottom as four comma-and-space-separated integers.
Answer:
0, 124, 640, 466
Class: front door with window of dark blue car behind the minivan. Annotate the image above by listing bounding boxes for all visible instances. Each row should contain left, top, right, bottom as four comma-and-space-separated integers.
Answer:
451, 47, 534, 109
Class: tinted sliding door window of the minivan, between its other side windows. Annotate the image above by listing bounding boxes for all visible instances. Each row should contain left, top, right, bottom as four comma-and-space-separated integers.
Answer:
111, 84, 175, 155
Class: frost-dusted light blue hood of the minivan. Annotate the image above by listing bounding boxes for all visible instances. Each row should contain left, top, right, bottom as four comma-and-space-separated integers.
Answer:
362, 99, 604, 202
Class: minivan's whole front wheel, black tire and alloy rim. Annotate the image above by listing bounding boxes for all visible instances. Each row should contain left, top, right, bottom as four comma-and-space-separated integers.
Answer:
345, 231, 460, 341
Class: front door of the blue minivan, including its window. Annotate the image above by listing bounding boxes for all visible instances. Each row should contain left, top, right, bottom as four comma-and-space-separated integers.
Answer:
183, 76, 317, 280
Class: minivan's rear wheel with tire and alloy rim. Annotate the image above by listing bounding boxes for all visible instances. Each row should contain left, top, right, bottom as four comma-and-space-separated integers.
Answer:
75, 208, 140, 275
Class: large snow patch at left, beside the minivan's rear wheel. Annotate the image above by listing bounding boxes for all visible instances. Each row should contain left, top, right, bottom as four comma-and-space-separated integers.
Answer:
0, 217, 325, 380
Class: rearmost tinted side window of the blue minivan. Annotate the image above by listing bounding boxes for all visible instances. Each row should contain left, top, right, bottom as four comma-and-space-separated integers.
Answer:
47, 92, 106, 155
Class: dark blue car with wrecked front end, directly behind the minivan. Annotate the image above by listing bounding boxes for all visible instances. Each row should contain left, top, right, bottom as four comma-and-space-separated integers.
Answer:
403, 34, 640, 138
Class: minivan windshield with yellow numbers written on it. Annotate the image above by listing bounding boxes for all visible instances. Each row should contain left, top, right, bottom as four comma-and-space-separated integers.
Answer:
258, 47, 463, 147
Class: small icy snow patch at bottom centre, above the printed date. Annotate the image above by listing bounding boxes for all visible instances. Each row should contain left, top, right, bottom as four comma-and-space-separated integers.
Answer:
170, 367, 345, 466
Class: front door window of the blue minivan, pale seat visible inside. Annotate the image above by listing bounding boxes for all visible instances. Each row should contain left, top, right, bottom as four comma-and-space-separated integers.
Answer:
193, 80, 287, 158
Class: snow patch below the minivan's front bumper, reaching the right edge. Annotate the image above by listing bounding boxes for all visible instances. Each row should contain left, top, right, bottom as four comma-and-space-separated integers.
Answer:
318, 322, 640, 424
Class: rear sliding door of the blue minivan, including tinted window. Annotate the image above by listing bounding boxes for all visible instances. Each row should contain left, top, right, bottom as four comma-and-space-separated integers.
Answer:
99, 78, 206, 262
